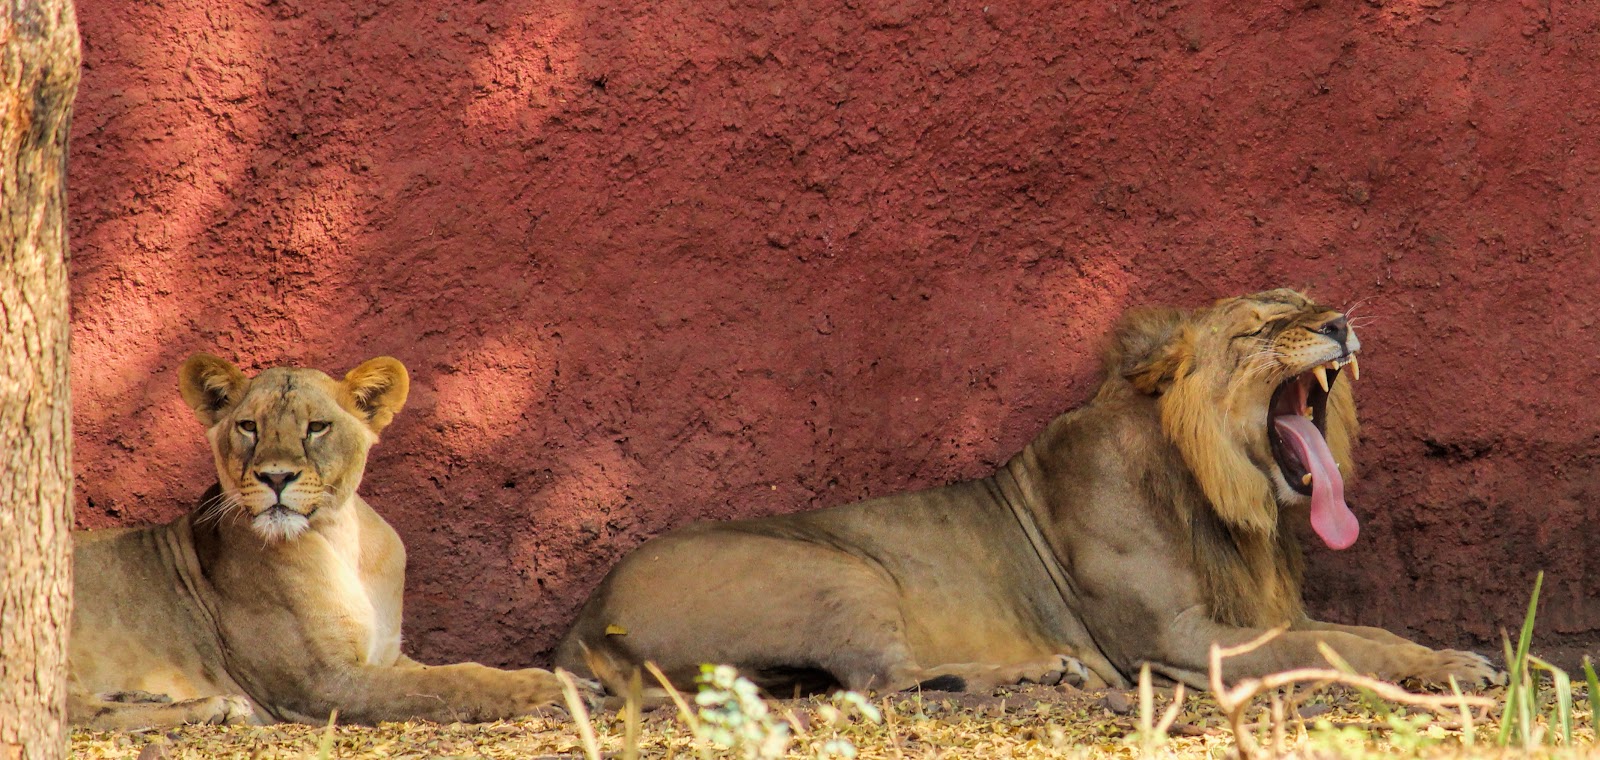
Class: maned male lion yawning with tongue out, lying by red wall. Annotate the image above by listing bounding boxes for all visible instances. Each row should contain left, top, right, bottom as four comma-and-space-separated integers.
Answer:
557, 290, 1496, 694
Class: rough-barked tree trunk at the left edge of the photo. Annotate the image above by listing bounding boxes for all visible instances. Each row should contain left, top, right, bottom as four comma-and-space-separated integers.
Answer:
0, 0, 78, 760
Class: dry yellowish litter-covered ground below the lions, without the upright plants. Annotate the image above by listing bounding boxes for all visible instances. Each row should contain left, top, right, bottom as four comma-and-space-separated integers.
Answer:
72, 686, 1594, 760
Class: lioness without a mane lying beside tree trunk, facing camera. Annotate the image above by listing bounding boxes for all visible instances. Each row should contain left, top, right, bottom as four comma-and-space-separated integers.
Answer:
69, 354, 588, 730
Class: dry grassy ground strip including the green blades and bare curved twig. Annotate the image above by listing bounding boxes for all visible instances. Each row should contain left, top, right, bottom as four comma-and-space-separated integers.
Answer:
72, 595, 1600, 760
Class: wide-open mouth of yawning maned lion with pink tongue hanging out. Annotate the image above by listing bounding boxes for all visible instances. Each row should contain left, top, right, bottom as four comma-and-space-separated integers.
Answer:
1267, 355, 1360, 549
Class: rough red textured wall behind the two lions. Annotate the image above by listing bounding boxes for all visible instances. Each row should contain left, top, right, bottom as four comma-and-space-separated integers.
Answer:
70, 0, 1600, 664
